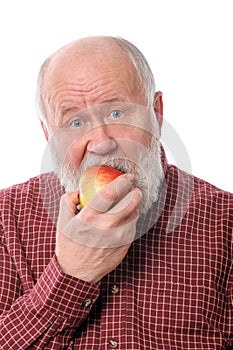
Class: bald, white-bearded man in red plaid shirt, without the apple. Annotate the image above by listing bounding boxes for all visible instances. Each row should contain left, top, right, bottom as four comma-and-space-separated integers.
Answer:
0, 37, 233, 350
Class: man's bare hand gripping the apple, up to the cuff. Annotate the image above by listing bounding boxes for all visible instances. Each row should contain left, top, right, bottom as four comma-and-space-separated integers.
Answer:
56, 174, 142, 283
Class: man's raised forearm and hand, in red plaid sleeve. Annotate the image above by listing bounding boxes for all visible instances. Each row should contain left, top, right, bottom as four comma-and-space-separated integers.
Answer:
0, 175, 141, 350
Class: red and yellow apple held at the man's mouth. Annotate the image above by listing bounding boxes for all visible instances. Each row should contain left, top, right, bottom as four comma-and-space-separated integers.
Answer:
79, 165, 123, 208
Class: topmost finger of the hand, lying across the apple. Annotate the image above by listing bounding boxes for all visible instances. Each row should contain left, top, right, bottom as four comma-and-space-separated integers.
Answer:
83, 174, 134, 213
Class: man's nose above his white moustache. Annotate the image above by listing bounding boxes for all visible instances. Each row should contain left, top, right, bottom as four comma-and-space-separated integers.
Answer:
87, 126, 117, 155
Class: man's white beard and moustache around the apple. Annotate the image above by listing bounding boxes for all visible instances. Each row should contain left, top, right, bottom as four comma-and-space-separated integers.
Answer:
57, 138, 163, 215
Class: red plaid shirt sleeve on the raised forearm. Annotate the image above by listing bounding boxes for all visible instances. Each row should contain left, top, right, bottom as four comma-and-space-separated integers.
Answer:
0, 256, 99, 349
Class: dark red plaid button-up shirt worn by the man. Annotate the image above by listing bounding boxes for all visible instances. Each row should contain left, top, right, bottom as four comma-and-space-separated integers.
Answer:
0, 154, 233, 350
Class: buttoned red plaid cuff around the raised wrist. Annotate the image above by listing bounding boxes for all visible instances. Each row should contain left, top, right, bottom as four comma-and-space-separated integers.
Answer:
30, 256, 100, 327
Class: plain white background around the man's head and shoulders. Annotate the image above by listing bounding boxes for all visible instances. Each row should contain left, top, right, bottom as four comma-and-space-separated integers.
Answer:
0, 0, 233, 192
